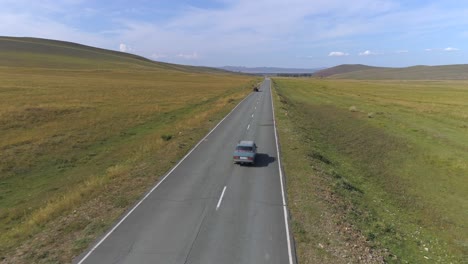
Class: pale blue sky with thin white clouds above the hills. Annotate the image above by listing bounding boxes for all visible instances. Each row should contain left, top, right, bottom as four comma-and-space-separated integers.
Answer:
0, 0, 468, 68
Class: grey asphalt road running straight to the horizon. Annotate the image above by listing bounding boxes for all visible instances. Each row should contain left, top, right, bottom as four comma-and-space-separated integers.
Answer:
75, 79, 296, 264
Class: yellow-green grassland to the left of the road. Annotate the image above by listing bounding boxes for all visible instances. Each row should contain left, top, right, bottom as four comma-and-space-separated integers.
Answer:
0, 36, 258, 263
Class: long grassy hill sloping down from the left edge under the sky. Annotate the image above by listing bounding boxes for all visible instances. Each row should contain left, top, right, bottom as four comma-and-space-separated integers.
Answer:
0, 36, 225, 73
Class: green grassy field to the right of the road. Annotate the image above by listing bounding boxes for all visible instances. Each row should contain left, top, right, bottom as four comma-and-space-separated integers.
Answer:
274, 78, 468, 263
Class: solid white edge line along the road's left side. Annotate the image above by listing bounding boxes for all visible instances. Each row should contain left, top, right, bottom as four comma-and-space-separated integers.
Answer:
77, 95, 250, 264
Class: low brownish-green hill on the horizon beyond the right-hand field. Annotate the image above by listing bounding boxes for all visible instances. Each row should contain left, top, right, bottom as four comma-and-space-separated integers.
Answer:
314, 64, 468, 80
